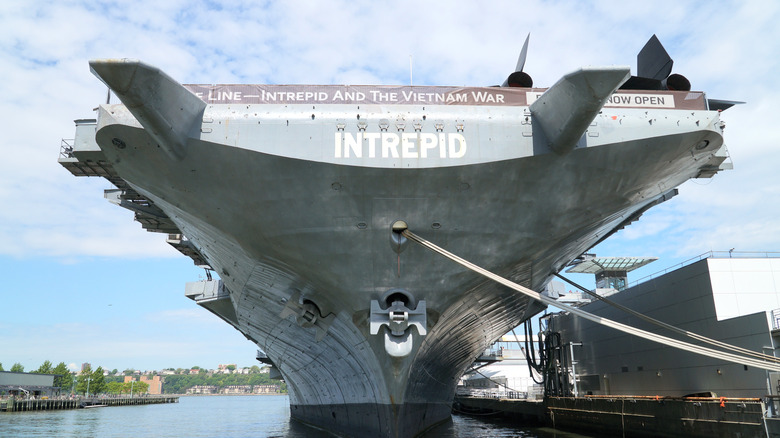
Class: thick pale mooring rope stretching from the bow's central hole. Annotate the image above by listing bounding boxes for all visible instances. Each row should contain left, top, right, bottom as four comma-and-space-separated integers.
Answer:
401, 229, 780, 371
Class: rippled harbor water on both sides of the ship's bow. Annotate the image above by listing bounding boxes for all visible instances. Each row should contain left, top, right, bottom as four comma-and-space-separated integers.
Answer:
0, 395, 582, 438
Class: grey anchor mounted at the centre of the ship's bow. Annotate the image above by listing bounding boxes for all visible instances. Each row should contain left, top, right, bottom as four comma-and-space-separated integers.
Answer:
369, 290, 427, 357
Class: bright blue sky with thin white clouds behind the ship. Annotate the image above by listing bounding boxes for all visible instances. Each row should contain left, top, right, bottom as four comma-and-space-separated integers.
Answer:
0, 0, 780, 370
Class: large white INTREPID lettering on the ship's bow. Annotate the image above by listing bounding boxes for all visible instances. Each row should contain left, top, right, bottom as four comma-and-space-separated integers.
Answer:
334, 131, 467, 159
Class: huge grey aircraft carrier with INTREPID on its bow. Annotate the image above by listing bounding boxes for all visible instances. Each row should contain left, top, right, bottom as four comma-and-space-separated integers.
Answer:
59, 36, 729, 437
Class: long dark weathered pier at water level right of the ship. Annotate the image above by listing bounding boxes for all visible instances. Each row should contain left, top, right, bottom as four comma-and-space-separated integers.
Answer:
453, 395, 780, 438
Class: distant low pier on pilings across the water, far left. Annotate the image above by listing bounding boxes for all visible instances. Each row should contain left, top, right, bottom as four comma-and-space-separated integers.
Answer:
0, 395, 179, 412
